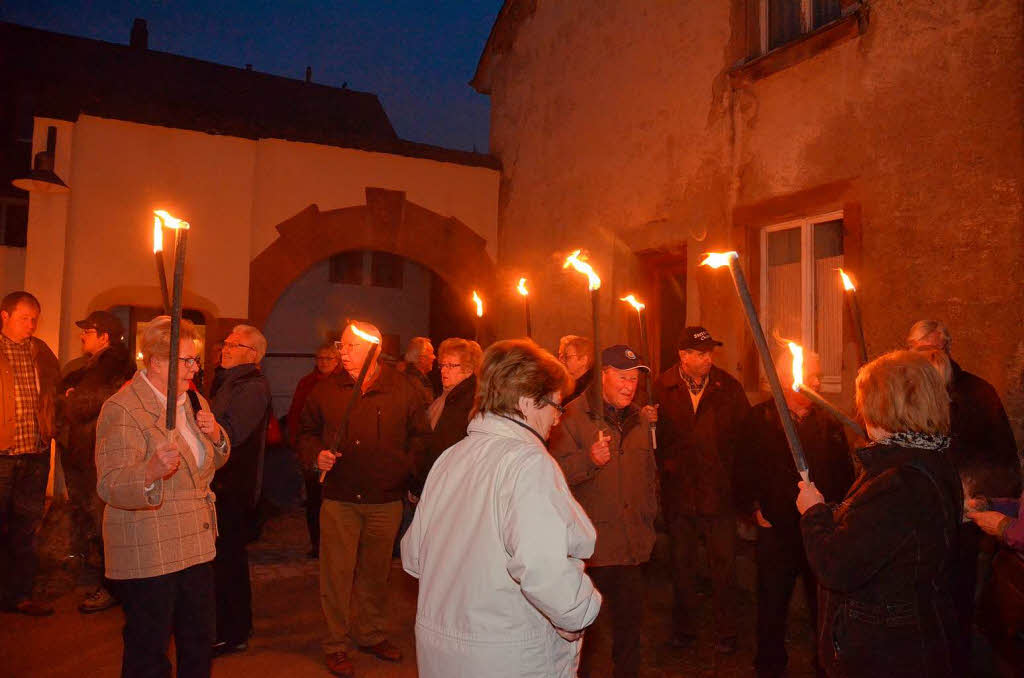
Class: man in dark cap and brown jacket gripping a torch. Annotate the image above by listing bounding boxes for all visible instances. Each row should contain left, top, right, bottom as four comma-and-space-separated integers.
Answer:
550, 345, 657, 678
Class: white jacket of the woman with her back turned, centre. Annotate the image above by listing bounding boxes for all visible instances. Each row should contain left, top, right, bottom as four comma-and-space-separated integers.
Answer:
401, 415, 601, 678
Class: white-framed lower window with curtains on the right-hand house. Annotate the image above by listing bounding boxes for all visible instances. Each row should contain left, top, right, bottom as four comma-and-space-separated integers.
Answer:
761, 212, 844, 393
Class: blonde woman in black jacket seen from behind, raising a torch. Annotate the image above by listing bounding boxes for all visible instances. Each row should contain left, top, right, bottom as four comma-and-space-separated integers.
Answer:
797, 351, 963, 678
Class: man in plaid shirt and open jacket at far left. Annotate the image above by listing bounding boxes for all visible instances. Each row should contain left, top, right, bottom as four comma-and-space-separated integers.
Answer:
0, 292, 60, 617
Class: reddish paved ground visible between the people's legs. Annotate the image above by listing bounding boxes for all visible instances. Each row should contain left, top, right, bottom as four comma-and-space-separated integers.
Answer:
0, 511, 813, 678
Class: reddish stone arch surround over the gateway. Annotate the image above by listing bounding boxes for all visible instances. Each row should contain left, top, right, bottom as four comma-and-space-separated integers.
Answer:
249, 186, 496, 328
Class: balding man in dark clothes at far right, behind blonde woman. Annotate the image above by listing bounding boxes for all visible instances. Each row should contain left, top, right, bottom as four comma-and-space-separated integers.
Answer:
906, 321, 1021, 671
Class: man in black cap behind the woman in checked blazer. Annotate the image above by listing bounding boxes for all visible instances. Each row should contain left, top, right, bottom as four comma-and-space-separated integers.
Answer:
58, 310, 135, 613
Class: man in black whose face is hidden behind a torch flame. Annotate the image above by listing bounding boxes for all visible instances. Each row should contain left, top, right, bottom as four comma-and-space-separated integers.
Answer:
736, 352, 854, 678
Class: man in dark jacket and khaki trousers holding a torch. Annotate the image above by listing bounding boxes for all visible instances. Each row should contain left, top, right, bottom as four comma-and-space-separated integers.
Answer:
299, 323, 430, 676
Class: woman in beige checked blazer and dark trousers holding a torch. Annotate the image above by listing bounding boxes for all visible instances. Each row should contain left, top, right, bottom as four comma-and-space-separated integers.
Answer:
96, 315, 229, 678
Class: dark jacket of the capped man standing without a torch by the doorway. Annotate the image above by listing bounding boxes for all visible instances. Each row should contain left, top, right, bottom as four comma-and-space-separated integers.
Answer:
654, 364, 751, 519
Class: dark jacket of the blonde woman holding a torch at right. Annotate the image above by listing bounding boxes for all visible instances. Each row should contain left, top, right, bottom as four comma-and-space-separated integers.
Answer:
801, 446, 963, 678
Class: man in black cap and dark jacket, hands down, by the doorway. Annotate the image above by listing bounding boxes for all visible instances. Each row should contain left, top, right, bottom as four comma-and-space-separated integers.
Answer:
654, 327, 751, 653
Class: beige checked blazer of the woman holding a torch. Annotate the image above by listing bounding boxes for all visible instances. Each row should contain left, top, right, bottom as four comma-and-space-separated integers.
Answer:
96, 373, 229, 580
